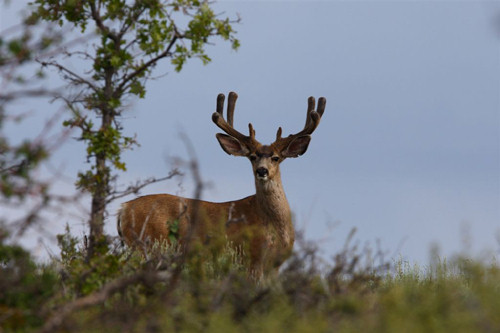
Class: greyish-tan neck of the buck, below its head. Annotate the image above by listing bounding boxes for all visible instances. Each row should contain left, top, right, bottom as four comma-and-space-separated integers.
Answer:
255, 173, 294, 244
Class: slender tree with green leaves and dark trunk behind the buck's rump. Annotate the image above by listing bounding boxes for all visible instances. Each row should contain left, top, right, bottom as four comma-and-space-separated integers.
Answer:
28, 0, 239, 256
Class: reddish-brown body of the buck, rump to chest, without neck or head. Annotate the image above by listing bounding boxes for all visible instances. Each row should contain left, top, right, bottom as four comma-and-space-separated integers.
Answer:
118, 194, 293, 272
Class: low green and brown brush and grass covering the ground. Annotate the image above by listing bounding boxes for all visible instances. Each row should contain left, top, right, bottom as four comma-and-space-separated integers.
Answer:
0, 227, 500, 332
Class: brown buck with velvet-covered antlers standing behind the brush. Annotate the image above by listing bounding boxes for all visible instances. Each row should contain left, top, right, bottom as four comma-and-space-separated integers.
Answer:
117, 92, 326, 274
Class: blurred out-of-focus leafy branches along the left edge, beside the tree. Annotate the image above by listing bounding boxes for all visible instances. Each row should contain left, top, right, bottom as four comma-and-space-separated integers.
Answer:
0, 3, 63, 223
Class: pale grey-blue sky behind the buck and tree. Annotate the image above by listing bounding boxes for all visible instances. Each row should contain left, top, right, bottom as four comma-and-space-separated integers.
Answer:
1, 1, 500, 262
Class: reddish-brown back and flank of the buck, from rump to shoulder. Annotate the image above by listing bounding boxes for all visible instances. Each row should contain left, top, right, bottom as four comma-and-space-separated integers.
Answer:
118, 194, 260, 245
